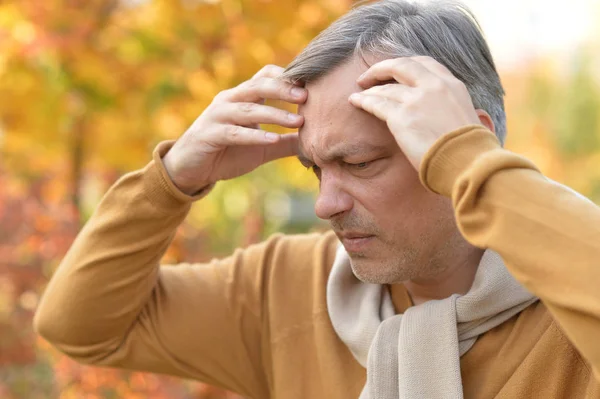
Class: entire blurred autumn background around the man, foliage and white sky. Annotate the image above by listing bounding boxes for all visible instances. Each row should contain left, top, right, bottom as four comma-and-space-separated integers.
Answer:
0, 0, 600, 399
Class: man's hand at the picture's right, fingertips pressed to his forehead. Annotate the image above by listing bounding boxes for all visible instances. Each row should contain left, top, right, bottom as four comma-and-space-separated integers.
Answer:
349, 57, 481, 171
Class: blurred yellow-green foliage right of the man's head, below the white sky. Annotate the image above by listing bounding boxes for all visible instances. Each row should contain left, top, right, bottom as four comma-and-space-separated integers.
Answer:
505, 45, 600, 202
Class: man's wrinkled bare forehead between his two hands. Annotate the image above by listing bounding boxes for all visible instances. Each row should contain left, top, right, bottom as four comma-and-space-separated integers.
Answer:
298, 58, 393, 159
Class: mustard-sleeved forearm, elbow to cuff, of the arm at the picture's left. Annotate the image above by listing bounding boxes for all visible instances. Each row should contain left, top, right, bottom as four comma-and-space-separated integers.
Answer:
35, 146, 204, 355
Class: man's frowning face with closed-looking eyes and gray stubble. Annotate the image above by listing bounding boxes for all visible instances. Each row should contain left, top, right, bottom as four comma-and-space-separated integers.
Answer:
299, 58, 464, 284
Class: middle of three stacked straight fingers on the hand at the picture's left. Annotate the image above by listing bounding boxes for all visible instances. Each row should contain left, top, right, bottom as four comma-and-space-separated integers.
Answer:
215, 103, 304, 128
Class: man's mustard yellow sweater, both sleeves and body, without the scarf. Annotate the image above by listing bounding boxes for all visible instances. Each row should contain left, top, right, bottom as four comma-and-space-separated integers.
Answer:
35, 126, 600, 399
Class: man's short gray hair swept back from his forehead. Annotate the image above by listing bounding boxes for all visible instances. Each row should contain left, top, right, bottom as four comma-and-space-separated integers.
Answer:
283, 0, 506, 143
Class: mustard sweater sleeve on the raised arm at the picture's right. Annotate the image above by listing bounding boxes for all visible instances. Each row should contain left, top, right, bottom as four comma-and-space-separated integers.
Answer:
420, 126, 600, 380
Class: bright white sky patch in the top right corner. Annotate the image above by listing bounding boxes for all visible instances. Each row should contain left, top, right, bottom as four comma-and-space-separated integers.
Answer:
463, 0, 600, 68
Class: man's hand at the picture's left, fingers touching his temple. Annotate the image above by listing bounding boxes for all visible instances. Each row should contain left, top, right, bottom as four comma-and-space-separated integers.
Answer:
163, 65, 308, 195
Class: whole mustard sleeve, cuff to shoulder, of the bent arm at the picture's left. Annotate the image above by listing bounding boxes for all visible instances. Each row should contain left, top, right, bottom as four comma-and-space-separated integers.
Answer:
34, 143, 279, 398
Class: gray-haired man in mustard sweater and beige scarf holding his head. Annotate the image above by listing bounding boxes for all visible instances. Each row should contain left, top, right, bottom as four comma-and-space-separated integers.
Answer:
35, 0, 600, 399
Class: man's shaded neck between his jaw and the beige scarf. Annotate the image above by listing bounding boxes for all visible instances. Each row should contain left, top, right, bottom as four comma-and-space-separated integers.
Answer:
403, 247, 484, 305
